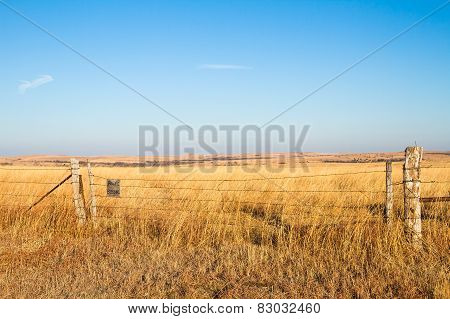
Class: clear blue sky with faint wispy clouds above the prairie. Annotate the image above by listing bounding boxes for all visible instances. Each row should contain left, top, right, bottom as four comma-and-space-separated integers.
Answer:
0, 0, 450, 155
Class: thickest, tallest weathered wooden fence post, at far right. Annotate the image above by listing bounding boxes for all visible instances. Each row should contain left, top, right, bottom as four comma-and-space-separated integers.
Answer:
403, 146, 423, 248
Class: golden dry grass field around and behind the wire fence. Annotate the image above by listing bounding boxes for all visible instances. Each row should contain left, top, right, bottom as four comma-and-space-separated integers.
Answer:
0, 156, 450, 298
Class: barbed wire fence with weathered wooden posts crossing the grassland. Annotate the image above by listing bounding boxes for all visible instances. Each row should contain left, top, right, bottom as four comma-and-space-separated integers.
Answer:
0, 147, 450, 242
